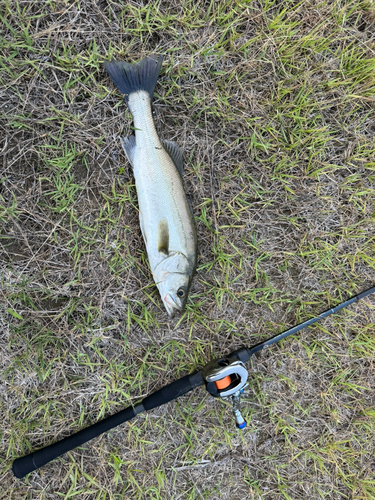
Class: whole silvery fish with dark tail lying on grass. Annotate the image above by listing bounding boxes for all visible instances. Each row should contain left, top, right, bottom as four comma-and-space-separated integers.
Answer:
105, 55, 197, 317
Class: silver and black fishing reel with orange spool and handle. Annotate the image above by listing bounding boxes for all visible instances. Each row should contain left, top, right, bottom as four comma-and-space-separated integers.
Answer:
202, 358, 249, 429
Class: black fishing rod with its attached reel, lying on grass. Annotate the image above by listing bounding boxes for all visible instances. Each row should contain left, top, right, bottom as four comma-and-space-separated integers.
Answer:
12, 286, 375, 478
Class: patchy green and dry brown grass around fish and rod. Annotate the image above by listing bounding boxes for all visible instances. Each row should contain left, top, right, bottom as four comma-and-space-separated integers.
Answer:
0, 0, 375, 500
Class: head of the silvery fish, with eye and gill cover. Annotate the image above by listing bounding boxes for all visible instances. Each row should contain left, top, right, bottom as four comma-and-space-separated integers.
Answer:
156, 253, 194, 317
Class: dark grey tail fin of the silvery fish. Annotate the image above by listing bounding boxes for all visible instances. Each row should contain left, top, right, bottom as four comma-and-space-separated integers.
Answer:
104, 55, 163, 104
